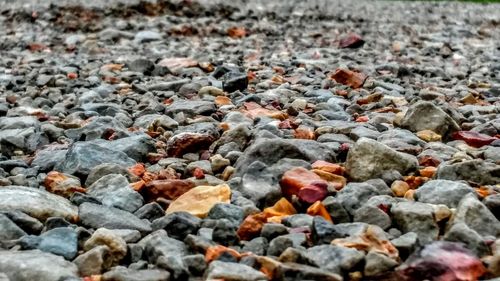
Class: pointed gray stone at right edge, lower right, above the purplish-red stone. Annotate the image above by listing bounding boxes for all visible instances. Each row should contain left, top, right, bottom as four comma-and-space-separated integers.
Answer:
450, 194, 500, 237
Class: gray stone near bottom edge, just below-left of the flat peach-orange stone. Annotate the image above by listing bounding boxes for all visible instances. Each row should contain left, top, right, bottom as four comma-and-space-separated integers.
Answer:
306, 245, 365, 274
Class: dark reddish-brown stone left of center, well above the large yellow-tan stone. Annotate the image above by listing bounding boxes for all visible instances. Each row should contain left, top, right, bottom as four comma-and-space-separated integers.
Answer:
167, 133, 215, 157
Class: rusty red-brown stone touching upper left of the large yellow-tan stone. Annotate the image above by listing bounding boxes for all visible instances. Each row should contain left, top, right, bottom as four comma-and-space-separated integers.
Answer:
144, 180, 195, 201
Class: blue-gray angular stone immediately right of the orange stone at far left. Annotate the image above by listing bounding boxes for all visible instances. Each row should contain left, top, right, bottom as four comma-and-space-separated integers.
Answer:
87, 174, 144, 212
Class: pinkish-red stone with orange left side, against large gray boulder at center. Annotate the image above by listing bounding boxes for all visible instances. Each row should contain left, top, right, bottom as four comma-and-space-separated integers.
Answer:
280, 167, 326, 198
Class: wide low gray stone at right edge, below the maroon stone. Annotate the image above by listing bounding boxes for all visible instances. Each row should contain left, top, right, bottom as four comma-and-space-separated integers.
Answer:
436, 159, 500, 185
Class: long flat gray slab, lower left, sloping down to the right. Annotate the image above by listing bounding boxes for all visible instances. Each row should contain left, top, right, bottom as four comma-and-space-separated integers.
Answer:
78, 203, 152, 233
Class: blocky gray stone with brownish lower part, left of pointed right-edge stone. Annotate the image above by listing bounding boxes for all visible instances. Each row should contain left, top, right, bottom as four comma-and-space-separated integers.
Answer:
391, 202, 439, 244
